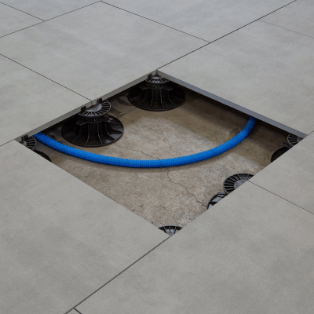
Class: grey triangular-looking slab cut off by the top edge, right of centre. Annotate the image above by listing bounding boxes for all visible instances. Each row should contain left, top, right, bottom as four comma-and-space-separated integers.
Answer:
103, 0, 291, 41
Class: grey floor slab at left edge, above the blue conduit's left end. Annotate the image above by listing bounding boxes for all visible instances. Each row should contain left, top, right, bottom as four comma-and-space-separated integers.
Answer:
0, 56, 90, 145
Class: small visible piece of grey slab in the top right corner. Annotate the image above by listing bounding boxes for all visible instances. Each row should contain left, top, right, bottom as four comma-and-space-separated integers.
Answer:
262, 0, 314, 37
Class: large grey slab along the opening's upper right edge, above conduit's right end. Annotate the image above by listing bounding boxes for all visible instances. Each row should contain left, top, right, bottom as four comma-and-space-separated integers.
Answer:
158, 21, 314, 136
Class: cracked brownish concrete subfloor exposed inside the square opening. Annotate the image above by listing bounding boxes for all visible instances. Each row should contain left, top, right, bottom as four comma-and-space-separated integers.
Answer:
37, 90, 286, 226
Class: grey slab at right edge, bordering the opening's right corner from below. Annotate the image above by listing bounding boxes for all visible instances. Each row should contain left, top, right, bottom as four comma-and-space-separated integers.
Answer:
252, 133, 314, 213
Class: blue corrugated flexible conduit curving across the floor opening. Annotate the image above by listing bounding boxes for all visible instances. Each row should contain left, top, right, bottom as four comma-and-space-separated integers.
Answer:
34, 117, 256, 168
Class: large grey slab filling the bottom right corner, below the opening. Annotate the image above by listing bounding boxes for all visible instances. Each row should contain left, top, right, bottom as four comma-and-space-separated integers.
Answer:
78, 182, 314, 314
